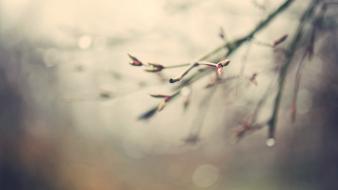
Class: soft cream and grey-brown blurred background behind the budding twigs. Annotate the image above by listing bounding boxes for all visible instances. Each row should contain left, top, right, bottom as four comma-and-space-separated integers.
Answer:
0, 0, 338, 190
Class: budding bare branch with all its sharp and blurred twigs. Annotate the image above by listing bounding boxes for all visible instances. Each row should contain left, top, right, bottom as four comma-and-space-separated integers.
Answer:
129, 0, 338, 146
